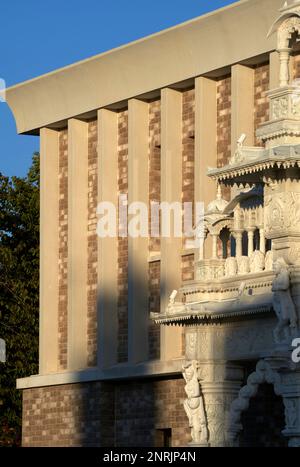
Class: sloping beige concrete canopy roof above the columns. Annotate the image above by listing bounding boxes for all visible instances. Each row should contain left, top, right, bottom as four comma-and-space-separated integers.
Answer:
6, 0, 283, 134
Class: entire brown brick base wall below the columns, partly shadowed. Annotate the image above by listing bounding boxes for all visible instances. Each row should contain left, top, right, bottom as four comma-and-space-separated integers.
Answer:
23, 378, 190, 447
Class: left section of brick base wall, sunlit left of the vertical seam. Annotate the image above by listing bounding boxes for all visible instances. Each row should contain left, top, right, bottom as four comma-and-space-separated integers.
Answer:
22, 383, 114, 447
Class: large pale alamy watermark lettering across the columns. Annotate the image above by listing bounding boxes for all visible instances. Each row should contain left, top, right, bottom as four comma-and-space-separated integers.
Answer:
97, 194, 204, 248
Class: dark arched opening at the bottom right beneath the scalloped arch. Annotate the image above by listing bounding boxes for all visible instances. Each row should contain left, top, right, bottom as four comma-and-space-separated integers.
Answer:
239, 383, 288, 447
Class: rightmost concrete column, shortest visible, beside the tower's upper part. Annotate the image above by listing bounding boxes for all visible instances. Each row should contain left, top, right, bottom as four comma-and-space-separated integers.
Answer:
231, 65, 254, 153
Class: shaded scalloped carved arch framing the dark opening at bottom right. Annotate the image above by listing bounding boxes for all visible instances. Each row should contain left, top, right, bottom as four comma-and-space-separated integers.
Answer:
228, 360, 283, 444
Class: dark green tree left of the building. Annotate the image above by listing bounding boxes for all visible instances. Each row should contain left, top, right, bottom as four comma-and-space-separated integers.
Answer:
0, 153, 39, 447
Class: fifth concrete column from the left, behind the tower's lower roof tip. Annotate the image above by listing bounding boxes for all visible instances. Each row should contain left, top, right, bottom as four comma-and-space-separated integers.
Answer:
160, 88, 182, 361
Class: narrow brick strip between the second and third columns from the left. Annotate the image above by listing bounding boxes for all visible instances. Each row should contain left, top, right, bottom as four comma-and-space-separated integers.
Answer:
87, 120, 98, 366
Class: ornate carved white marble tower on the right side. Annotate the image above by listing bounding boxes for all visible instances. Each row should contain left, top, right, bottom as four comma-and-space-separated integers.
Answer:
152, 1, 300, 447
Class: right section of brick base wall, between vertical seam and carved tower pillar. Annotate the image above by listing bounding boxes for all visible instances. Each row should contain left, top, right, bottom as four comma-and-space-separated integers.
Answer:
116, 378, 191, 447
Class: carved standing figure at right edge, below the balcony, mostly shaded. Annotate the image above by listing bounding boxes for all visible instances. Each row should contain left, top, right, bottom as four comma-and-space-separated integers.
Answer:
272, 258, 298, 344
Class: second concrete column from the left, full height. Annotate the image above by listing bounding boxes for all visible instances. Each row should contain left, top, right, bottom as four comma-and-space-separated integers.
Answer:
68, 119, 88, 370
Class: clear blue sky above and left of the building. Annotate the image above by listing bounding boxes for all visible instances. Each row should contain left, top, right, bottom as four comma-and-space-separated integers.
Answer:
0, 0, 235, 176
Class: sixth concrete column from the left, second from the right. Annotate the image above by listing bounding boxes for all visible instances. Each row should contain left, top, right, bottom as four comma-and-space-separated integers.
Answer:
195, 77, 217, 207
